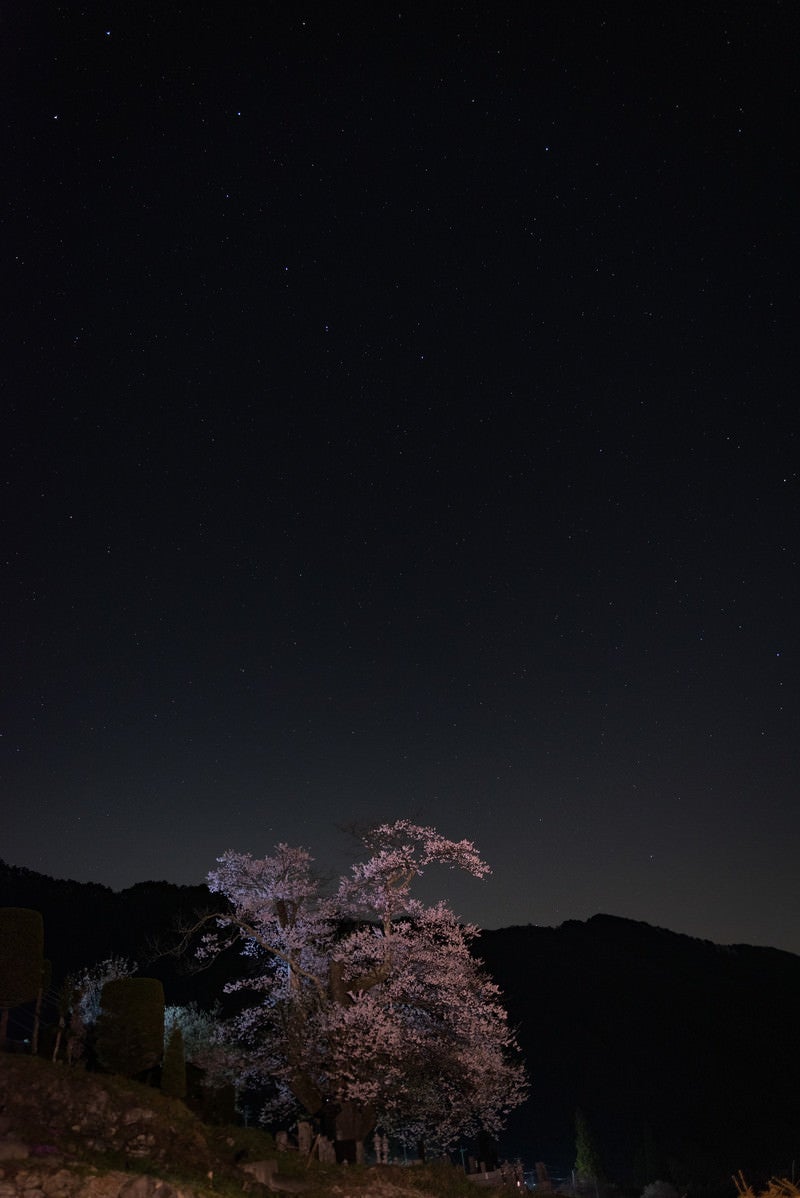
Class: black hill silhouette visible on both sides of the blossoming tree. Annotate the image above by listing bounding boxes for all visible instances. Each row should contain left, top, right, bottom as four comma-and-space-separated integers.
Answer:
0, 861, 800, 1194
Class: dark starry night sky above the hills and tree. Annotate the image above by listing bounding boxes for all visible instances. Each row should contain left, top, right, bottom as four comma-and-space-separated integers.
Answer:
6, 0, 800, 952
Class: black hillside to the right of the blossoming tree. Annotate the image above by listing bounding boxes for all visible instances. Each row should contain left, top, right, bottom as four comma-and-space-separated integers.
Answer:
478, 915, 800, 1186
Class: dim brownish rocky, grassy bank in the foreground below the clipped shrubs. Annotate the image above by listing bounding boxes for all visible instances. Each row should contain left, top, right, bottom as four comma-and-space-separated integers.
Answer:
0, 1054, 495, 1198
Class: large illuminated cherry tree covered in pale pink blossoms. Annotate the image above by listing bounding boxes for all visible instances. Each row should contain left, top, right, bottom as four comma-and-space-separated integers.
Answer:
200, 819, 526, 1148
